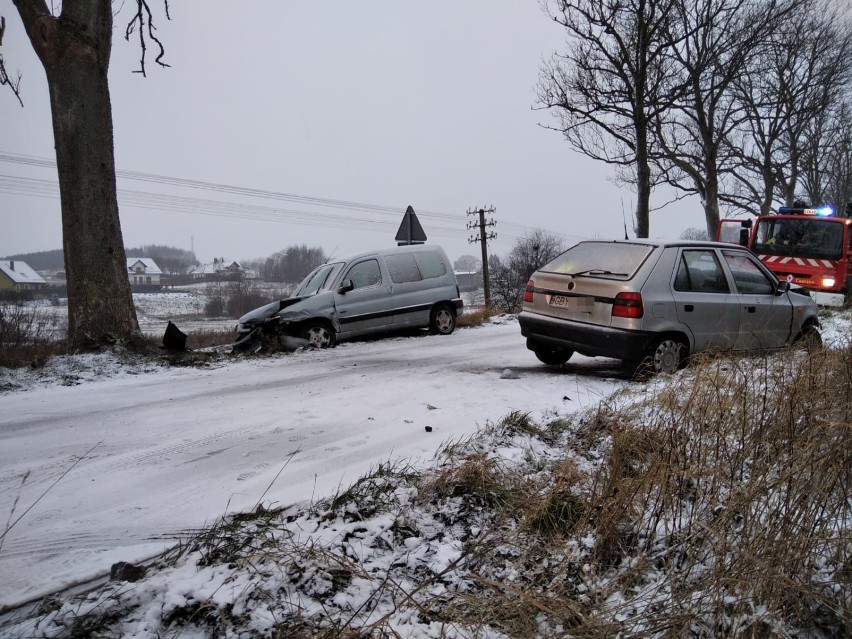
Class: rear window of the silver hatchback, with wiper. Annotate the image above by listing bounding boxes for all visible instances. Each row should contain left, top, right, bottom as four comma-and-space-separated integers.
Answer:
539, 242, 654, 280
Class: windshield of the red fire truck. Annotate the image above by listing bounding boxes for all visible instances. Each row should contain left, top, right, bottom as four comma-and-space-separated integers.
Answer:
752, 216, 843, 260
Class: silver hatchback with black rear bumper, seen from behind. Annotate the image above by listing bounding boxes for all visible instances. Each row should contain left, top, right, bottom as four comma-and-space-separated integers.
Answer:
518, 240, 821, 372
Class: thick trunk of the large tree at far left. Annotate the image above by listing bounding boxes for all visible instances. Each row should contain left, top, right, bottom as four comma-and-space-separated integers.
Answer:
15, 0, 139, 348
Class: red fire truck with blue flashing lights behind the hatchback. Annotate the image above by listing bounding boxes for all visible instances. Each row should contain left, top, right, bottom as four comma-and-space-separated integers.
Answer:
716, 207, 852, 306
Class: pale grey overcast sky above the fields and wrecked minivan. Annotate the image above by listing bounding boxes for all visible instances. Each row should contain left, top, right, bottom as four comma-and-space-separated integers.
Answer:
0, 0, 704, 262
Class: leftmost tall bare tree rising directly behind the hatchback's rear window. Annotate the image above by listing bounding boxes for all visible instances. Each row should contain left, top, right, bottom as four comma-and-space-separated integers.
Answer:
537, 0, 678, 237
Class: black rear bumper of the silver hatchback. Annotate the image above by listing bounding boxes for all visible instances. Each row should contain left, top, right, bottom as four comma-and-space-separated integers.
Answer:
518, 311, 658, 361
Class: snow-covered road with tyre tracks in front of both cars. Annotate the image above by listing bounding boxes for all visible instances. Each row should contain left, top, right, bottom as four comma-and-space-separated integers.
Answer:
0, 318, 624, 610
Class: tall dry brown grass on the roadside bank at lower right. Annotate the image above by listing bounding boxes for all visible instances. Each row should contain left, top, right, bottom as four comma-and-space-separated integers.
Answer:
460, 349, 852, 637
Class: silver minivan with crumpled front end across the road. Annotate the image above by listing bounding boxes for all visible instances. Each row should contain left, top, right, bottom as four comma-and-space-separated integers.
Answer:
234, 244, 463, 350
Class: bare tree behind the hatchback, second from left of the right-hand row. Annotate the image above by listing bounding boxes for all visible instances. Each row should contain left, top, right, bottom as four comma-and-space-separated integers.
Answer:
655, 0, 801, 237
